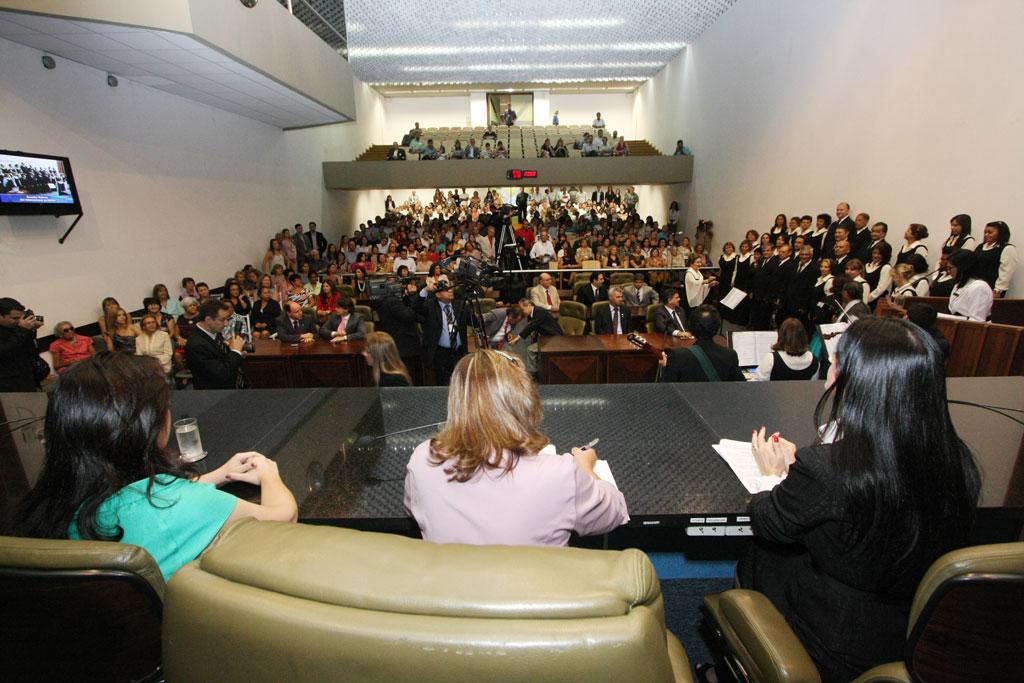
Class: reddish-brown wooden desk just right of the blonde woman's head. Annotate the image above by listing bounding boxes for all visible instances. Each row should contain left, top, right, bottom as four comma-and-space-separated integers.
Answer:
540, 335, 726, 384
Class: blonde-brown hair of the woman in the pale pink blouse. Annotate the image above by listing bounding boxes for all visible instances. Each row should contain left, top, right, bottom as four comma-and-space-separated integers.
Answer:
430, 349, 548, 481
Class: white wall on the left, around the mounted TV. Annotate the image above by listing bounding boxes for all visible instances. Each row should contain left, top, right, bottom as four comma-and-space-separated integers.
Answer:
0, 35, 383, 324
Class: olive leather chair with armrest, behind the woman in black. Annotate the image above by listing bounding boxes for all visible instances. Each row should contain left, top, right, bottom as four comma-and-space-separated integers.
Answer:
705, 543, 1024, 683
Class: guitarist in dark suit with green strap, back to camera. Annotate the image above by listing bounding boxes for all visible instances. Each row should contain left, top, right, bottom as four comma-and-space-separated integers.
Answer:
660, 305, 743, 382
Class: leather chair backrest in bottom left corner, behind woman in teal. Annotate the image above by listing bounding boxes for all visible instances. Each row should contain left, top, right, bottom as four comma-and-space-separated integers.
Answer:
0, 537, 164, 681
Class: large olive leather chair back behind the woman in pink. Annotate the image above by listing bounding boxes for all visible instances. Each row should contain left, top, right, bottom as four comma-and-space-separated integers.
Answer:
164, 520, 692, 683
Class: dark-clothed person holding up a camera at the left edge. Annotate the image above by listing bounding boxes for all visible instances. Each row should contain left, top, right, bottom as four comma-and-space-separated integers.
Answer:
0, 297, 50, 391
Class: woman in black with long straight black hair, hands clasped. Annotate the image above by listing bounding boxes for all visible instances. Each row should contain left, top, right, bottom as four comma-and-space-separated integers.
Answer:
737, 317, 980, 683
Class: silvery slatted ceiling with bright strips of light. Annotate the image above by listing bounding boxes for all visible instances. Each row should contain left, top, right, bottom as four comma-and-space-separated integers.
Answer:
345, 0, 735, 85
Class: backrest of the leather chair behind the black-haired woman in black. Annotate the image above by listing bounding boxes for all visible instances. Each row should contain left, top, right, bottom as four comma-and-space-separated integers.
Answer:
905, 543, 1024, 682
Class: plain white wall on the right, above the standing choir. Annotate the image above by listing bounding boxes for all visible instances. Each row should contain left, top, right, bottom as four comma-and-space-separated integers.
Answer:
635, 0, 1024, 296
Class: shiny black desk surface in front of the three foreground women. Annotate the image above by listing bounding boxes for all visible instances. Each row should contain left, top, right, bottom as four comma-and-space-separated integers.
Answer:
0, 377, 1024, 531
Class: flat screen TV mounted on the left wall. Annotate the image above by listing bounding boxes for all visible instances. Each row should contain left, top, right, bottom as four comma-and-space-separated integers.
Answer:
0, 150, 82, 216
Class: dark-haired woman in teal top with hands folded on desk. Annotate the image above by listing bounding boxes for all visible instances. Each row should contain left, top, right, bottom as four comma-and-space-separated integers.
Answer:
14, 353, 298, 580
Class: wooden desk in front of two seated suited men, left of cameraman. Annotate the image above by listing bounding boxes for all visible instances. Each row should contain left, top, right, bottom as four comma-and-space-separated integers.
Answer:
242, 339, 373, 389
